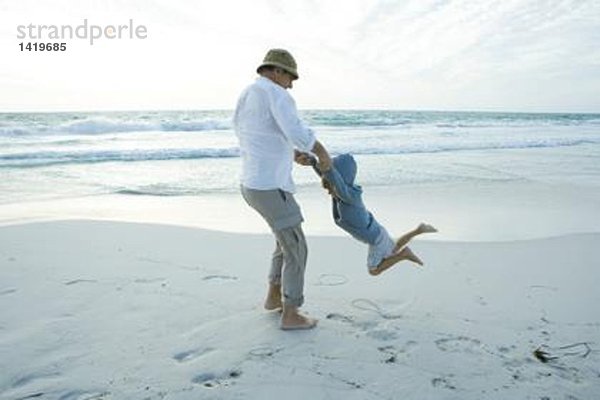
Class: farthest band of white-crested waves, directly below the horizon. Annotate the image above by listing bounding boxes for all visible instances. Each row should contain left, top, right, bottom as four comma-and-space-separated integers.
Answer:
0, 110, 600, 138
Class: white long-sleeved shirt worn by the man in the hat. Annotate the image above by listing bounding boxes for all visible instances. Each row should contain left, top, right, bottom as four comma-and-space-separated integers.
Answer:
233, 77, 316, 193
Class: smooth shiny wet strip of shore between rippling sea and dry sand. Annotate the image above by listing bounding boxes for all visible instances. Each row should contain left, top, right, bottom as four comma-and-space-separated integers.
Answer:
0, 182, 600, 242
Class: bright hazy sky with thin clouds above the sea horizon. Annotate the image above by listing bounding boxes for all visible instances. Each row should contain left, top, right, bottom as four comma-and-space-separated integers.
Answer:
0, 0, 600, 113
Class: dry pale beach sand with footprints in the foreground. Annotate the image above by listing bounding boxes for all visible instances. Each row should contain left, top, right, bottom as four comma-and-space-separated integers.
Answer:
0, 221, 600, 400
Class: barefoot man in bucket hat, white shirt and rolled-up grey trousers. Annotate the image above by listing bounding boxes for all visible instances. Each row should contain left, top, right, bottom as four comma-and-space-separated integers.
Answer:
234, 49, 331, 330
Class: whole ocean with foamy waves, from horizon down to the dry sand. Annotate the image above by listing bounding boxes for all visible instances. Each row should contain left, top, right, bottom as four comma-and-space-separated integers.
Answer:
0, 110, 600, 239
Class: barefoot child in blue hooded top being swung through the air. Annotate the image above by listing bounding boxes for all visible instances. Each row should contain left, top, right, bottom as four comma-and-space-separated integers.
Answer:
300, 153, 437, 276
